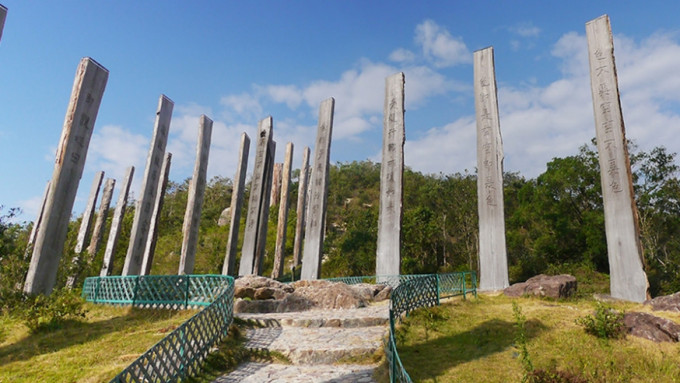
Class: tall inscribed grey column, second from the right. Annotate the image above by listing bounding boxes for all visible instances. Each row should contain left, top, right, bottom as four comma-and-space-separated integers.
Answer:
473, 47, 509, 291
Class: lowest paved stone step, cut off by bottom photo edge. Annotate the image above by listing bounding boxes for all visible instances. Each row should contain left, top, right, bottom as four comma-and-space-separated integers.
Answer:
213, 362, 378, 383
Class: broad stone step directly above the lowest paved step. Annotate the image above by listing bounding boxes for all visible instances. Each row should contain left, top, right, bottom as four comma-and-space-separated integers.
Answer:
245, 326, 388, 365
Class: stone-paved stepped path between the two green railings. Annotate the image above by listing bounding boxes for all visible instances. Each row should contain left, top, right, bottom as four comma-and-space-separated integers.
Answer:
213, 302, 389, 383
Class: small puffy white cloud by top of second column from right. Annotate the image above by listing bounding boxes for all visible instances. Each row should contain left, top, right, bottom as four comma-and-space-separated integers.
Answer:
415, 20, 472, 68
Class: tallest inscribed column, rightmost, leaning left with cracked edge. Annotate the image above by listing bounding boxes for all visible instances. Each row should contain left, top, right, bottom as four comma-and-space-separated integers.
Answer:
586, 15, 649, 302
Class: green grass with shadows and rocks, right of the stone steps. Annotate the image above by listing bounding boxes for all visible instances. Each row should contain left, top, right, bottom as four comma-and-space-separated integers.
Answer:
388, 294, 680, 382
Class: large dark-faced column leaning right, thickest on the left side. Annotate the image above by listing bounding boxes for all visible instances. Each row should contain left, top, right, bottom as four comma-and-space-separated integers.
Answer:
24, 57, 109, 294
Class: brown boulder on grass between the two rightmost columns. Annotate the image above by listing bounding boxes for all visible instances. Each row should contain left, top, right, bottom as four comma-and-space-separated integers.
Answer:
503, 274, 577, 299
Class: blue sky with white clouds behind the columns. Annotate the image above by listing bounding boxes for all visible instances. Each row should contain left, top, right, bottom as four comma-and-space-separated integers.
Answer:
0, 0, 680, 221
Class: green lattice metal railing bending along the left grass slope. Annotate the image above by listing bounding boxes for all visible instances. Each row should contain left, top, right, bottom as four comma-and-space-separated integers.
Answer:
83, 275, 234, 383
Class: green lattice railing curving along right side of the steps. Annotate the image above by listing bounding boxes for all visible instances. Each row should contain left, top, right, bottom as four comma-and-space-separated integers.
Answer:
385, 271, 477, 383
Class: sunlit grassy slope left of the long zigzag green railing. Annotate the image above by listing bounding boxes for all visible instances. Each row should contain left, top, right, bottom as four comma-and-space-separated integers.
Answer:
0, 304, 196, 382
